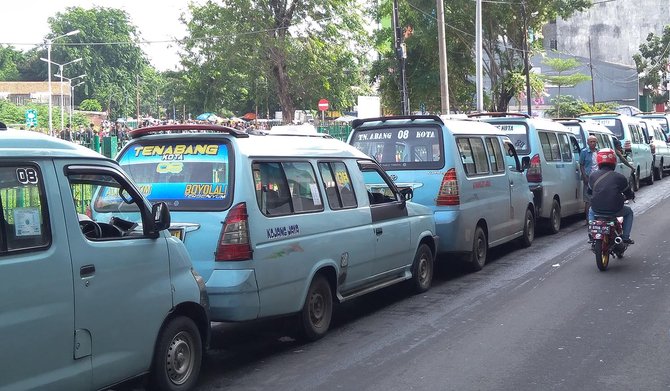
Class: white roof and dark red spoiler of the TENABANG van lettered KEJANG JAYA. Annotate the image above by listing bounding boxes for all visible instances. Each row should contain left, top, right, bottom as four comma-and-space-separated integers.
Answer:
124, 132, 369, 159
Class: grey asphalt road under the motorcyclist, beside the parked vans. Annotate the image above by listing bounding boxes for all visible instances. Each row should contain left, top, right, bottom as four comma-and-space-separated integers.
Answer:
119, 179, 670, 391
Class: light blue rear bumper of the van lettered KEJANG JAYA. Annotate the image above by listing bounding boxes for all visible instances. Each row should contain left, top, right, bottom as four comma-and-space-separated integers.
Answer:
205, 269, 260, 322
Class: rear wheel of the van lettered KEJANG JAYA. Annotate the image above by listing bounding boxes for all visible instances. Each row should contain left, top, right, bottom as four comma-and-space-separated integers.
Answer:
300, 275, 333, 341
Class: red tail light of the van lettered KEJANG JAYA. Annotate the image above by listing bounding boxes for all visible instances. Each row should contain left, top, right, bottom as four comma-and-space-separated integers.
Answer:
214, 202, 252, 262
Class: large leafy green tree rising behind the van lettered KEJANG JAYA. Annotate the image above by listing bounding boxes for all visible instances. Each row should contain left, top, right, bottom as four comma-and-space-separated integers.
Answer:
181, 0, 367, 121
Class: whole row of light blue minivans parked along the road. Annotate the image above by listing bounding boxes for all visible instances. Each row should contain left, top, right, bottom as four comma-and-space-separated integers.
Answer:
0, 114, 670, 390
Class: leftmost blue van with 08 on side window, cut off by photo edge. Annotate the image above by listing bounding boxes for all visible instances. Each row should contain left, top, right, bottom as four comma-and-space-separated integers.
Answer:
0, 123, 210, 391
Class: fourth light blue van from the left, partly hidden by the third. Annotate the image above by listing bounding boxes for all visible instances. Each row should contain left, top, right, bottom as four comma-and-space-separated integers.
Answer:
474, 113, 584, 234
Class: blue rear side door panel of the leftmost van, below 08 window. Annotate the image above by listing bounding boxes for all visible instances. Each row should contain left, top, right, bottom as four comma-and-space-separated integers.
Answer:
0, 162, 91, 390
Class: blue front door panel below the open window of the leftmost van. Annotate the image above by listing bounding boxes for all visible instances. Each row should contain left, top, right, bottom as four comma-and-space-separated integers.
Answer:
56, 162, 172, 389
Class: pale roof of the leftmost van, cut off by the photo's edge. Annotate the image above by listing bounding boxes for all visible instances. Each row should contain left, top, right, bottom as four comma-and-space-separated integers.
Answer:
0, 128, 106, 159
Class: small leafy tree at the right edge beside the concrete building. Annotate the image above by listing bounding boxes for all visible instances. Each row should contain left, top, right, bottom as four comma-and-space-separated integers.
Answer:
633, 25, 670, 103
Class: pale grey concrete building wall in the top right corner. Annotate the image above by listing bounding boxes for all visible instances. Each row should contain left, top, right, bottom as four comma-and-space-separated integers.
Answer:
544, 0, 670, 66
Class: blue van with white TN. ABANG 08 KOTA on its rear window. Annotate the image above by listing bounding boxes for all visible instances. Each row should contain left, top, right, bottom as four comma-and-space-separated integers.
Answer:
349, 115, 535, 270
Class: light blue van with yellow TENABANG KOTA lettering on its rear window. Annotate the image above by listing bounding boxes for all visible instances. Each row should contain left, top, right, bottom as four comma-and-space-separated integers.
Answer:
117, 125, 437, 340
